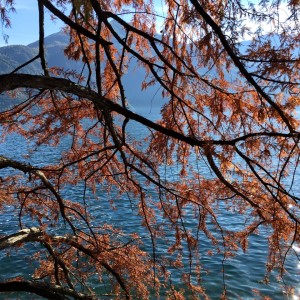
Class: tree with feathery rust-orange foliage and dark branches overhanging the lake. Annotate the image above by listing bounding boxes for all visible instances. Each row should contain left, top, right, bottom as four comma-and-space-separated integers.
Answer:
0, 0, 300, 299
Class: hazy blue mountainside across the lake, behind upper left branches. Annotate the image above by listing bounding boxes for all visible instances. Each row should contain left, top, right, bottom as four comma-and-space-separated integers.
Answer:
0, 32, 165, 113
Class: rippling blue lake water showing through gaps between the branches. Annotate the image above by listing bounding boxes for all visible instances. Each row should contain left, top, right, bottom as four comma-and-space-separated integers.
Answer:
0, 108, 300, 300
